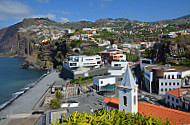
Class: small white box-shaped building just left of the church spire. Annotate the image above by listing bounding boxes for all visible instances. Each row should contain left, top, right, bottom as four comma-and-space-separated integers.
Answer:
93, 75, 116, 91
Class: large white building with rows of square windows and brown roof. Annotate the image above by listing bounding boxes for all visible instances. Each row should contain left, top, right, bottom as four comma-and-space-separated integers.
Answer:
143, 65, 190, 95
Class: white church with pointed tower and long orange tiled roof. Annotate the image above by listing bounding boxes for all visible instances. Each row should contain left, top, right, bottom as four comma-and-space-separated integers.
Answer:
102, 66, 190, 125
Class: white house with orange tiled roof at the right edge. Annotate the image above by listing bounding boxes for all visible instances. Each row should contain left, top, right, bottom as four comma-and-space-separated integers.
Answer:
165, 88, 190, 111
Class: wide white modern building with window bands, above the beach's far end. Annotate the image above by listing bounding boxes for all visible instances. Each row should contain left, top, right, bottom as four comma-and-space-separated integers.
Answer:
67, 55, 102, 69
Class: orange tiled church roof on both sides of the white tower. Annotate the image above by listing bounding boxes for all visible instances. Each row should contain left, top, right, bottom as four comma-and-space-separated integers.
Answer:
102, 98, 190, 124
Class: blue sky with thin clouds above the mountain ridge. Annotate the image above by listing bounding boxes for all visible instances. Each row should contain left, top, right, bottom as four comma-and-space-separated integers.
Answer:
0, 0, 190, 28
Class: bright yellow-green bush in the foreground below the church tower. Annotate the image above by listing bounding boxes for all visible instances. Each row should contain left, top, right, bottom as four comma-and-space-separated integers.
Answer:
52, 108, 171, 125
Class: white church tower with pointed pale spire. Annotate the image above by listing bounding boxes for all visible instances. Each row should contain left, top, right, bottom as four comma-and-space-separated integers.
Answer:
119, 65, 138, 113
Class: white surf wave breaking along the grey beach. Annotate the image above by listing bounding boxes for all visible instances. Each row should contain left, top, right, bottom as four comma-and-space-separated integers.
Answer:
0, 73, 47, 110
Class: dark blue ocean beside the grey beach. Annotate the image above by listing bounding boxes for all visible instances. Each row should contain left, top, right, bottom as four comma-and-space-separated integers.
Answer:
0, 57, 46, 109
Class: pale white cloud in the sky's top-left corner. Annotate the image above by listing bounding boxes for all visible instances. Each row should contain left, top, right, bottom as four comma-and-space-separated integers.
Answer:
0, 0, 32, 21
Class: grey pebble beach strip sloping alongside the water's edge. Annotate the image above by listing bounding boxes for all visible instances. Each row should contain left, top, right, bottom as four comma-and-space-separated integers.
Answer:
0, 72, 60, 118
